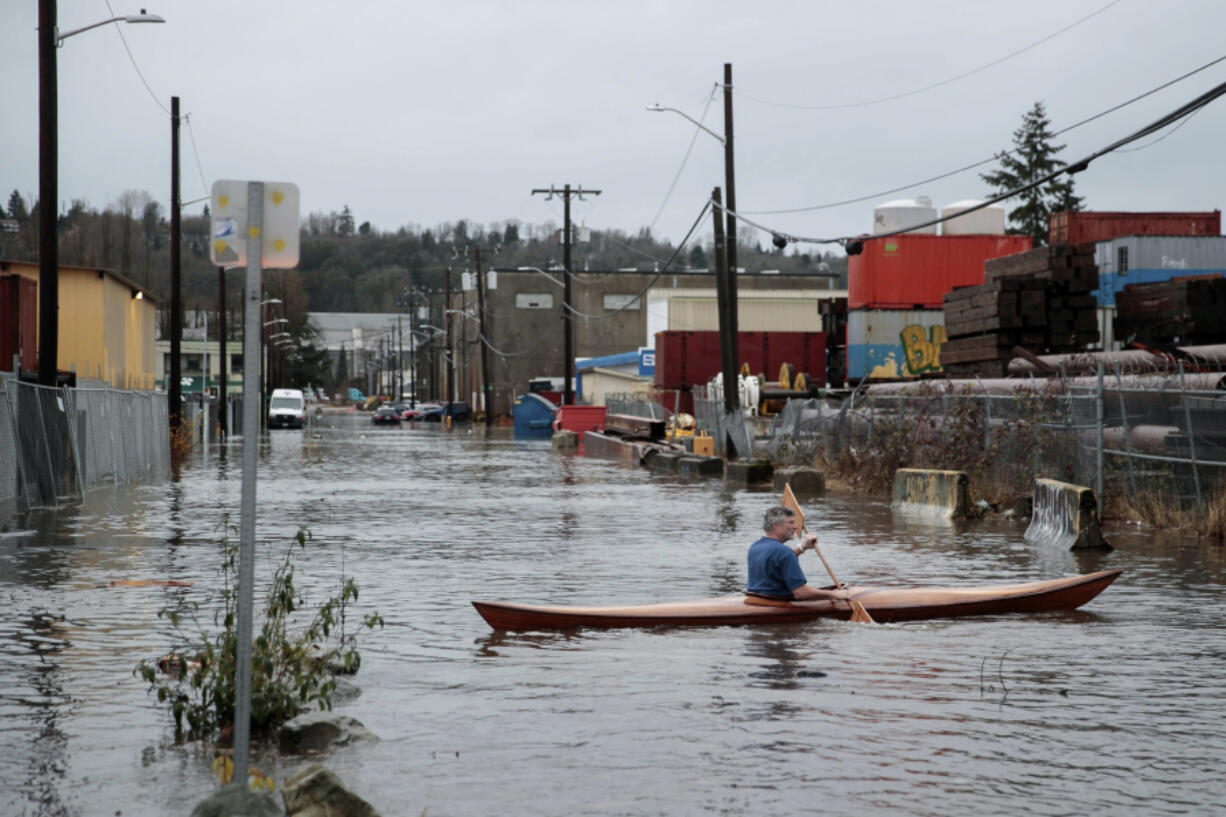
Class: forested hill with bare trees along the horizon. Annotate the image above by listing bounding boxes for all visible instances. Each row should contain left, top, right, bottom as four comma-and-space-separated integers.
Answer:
0, 191, 846, 318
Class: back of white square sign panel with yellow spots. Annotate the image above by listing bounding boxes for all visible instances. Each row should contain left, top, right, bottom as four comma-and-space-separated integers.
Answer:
208, 179, 298, 269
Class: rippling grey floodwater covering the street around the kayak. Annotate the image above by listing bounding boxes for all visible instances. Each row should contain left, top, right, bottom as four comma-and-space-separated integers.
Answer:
0, 416, 1226, 817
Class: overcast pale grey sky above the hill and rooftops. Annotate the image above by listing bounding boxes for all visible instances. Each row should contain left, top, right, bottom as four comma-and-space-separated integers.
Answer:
0, 0, 1226, 255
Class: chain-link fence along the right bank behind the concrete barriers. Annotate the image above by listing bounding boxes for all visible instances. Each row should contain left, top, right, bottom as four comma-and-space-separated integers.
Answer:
755, 372, 1226, 507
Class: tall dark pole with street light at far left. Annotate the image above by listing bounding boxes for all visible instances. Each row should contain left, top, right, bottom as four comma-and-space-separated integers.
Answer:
38, 0, 166, 386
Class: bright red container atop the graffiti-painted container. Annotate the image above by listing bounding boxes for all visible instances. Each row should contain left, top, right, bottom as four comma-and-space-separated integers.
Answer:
847, 236, 1031, 309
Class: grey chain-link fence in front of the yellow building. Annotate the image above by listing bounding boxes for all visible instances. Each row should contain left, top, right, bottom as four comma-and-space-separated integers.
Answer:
0, 378, 170, 509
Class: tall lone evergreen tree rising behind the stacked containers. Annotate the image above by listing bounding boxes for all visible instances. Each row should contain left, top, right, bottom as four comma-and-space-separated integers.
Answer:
980, 102, 1083, 247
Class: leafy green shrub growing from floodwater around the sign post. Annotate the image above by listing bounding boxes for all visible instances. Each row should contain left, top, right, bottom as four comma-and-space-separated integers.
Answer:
134, 527, 384, 740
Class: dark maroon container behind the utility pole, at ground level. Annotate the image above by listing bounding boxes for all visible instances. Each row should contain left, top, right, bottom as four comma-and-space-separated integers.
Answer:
655, 330, 826, 387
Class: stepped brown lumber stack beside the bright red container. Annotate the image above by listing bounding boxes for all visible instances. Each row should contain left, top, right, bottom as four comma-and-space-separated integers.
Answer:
940, 244, 1098, 377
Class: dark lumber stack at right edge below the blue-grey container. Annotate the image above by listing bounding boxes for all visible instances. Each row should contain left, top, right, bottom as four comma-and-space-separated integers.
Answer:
1116, 274, 1226, 346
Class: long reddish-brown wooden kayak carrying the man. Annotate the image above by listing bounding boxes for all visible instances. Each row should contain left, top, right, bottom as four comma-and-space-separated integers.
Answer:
472, 570, 1119, 631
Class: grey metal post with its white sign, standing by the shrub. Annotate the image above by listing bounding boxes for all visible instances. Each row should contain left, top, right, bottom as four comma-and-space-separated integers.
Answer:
208, 180, 298, 784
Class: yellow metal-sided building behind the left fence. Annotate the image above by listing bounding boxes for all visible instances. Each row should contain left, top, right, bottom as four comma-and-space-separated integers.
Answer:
0, 261, 157, 389
